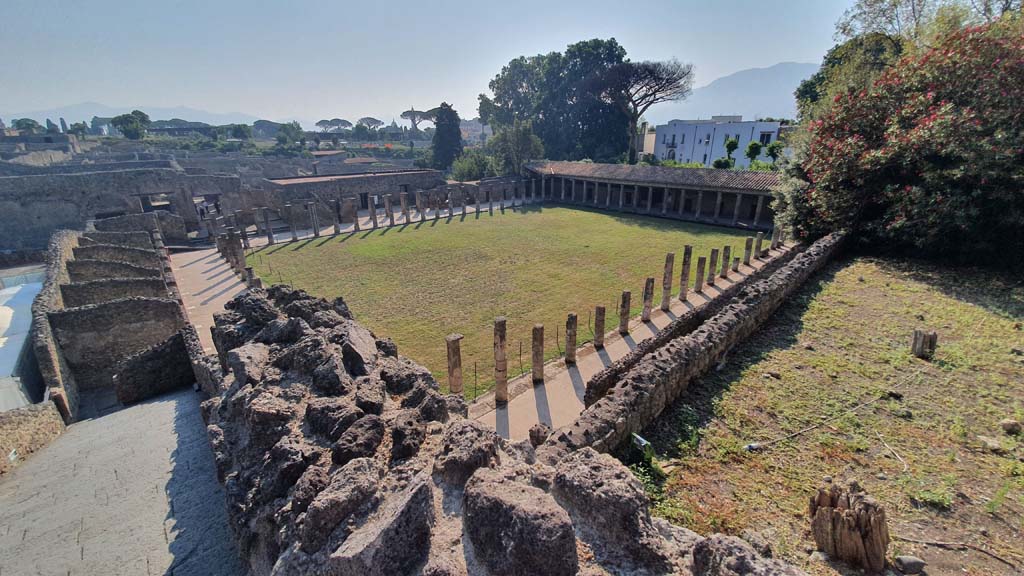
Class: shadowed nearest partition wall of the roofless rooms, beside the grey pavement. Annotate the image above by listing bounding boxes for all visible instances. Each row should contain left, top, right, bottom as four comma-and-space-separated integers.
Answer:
114, 332, 196, 404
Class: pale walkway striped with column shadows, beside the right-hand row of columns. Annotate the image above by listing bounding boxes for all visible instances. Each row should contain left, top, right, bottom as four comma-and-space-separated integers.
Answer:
469, 241, 782, 441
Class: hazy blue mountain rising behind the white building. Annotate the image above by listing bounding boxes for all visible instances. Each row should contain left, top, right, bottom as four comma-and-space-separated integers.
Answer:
644, 63, 818, 124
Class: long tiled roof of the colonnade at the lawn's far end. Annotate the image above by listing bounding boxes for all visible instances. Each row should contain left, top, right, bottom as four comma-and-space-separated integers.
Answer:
526, 161, 778, 193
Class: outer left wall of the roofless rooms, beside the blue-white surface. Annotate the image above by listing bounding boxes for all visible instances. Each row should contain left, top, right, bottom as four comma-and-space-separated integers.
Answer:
30, 231, 81, 416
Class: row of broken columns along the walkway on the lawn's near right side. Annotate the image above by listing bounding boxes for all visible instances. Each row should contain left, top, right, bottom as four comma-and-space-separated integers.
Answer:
445, 230, 785, 403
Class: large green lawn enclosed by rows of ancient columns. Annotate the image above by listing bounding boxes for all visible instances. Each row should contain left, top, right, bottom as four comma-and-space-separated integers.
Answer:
243, 203, 746, 396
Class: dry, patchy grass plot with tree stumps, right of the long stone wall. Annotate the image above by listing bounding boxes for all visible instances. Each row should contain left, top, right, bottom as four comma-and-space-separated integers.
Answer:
635, 257, 1024, 575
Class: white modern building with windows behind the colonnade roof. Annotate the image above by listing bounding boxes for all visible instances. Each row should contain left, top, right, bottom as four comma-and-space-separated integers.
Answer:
654, 116, 780, 168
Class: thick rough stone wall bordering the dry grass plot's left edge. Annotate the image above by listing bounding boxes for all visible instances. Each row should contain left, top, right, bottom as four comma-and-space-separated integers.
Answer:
538, 234, 845, 462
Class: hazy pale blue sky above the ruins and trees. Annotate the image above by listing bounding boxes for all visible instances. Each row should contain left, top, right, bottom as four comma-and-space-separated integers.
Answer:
0, 0, 851, 122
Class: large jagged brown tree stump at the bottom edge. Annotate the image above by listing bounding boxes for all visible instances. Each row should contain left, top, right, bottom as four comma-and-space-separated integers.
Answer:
810, 482, 889, 574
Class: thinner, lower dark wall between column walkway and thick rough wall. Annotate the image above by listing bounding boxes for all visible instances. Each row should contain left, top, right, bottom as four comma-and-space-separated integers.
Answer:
584, 245, 803, 406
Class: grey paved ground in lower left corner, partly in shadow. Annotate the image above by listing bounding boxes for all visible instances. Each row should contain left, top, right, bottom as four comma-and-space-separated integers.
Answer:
0, 389, 245, 576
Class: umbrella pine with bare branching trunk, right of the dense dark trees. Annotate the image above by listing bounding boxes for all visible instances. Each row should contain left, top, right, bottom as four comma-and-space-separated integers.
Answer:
590, 60, 693, 164
